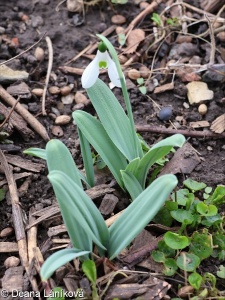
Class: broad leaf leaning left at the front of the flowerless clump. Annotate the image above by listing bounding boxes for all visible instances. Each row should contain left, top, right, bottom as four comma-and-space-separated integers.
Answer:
48, 171, 109, 255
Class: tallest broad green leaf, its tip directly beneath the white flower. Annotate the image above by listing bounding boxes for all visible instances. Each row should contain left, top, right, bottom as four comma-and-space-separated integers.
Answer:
87, 79, 141, 160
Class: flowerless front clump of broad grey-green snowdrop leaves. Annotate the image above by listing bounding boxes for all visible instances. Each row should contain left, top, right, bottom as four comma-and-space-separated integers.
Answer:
24, 140, 177, 280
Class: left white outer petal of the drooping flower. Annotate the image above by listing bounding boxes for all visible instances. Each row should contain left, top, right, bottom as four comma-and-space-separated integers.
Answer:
81, 55, 99, 89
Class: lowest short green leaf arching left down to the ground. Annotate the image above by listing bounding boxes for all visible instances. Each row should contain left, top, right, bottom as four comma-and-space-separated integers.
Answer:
40, 248, 89, 281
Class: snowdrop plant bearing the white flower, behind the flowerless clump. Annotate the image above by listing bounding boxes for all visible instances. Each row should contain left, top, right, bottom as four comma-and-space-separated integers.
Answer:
73, 35, 185, 199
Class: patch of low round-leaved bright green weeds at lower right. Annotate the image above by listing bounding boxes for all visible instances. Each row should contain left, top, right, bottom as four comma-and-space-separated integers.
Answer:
152, 178, 225, 300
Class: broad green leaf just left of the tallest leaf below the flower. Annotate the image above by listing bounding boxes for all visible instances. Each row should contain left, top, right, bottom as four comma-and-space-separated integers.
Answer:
73, 110, 127, 187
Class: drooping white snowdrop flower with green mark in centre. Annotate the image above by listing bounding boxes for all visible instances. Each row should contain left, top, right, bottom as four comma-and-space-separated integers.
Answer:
81, 50, 121, 89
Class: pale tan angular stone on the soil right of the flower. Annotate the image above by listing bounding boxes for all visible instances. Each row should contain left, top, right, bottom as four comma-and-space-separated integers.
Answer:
186, 81, 214, 105
